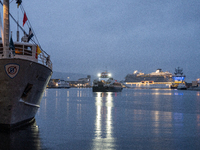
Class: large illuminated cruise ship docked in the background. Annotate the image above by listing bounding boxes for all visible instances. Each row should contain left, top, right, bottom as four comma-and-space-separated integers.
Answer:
124, 69, 173, 88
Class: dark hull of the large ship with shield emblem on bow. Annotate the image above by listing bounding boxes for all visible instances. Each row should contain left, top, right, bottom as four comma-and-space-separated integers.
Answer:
0, 59, 52, 128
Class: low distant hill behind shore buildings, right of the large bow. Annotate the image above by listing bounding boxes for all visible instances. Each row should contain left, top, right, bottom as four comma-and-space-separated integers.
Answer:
51, 71, 94, 81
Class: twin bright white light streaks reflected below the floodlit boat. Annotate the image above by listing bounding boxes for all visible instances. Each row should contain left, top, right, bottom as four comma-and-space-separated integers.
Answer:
93, 92, 117, 150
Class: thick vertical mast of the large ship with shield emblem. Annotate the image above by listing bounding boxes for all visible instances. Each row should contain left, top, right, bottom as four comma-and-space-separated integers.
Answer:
3, 0, 10, 58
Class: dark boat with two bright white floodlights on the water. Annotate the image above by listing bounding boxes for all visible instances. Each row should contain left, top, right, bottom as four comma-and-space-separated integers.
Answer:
92, 71, 123, 92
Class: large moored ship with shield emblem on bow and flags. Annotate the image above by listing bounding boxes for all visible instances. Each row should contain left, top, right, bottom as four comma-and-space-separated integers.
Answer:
0, 0, 52, 130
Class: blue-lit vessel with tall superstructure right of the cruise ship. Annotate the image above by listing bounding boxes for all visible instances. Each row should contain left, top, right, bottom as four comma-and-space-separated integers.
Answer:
171, 67, 187, 90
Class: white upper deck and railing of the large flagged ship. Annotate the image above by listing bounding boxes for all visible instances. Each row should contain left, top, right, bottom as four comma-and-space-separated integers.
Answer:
0, 37, 52, 69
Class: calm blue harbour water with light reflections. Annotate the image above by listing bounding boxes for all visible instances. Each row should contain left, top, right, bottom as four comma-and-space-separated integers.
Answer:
0, 88, 200, 150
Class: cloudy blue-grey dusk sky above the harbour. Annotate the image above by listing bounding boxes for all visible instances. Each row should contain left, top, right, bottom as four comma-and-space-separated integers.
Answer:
5, 0, 200, 82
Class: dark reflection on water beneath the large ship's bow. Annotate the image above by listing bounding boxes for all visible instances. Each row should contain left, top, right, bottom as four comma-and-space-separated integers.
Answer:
0, 122, 41, 150
